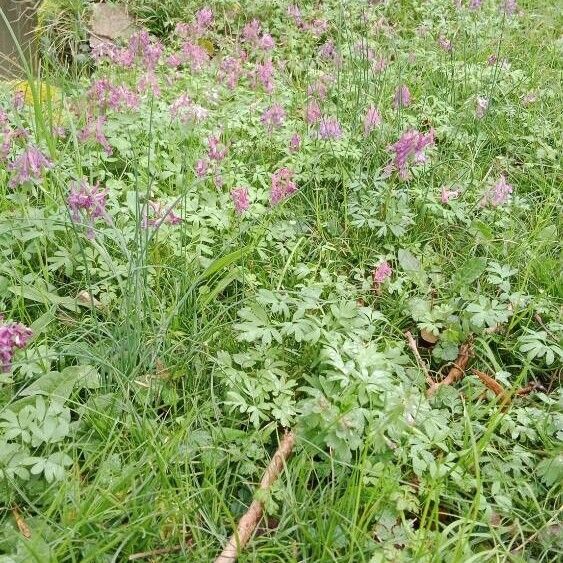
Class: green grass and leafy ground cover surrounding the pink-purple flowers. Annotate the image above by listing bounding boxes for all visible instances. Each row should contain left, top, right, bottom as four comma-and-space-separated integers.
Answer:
0, 0, 563, 563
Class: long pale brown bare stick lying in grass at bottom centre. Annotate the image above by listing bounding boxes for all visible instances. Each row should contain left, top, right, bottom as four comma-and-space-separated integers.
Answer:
215, 431, 295, 563
